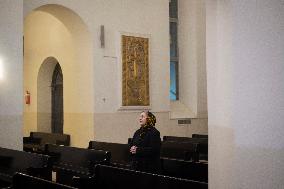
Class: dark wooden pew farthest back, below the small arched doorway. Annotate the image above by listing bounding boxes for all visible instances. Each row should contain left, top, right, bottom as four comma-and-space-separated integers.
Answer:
23, 132, 70, 153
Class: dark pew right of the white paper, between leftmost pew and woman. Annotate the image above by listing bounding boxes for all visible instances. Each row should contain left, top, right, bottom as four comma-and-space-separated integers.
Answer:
45, 144, 111, 185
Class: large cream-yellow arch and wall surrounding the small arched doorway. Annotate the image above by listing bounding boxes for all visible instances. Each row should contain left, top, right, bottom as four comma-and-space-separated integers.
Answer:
24, 4, 94, 146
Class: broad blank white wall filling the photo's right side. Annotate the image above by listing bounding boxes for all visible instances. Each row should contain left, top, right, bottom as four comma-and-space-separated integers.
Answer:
206, 0, 284, 189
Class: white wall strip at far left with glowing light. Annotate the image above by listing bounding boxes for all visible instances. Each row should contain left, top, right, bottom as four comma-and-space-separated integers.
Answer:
0, 0, 23, 150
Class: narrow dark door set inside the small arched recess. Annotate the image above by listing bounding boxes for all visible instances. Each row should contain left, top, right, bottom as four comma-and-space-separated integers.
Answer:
51, 63, 63, 134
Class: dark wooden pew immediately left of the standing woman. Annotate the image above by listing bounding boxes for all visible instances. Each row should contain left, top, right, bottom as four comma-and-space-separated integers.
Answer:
88, 141, 130, 168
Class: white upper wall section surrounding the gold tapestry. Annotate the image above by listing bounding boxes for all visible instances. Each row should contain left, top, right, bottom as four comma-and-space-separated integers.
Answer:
93, 0, 169, 113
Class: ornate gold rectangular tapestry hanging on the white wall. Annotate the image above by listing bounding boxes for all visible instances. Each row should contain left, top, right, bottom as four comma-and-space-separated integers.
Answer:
122, 35, 150, 106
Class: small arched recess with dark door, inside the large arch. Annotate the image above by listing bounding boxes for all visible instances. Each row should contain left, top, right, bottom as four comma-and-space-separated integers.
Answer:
37, 56, 64, 133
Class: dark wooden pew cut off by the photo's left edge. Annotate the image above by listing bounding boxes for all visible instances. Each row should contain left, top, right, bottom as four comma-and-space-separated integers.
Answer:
0, 148, 51, 185
